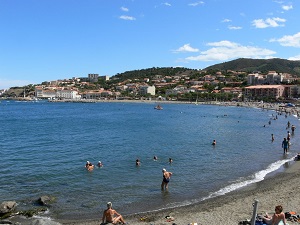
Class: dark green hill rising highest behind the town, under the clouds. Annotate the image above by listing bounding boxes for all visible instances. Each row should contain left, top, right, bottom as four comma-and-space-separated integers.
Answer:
205, 58, 300, 76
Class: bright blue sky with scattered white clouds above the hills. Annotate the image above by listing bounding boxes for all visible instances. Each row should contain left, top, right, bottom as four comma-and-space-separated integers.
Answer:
0, 0, 300, 89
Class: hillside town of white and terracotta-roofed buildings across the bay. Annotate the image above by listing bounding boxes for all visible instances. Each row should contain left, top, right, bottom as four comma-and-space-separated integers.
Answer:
0, 67, 300, 102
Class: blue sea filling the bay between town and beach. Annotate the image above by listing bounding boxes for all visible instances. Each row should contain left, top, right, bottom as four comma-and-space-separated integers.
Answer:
0, 100, 300, 221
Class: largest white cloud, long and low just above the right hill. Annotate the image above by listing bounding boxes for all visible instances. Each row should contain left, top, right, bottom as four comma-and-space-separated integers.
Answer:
186, 41, 276, 61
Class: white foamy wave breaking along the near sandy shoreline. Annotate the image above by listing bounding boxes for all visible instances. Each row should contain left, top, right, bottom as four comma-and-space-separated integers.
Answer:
202, 158, 293, 200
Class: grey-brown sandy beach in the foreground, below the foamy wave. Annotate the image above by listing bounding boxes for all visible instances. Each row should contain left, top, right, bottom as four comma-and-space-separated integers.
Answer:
54, 158, 300, 225
